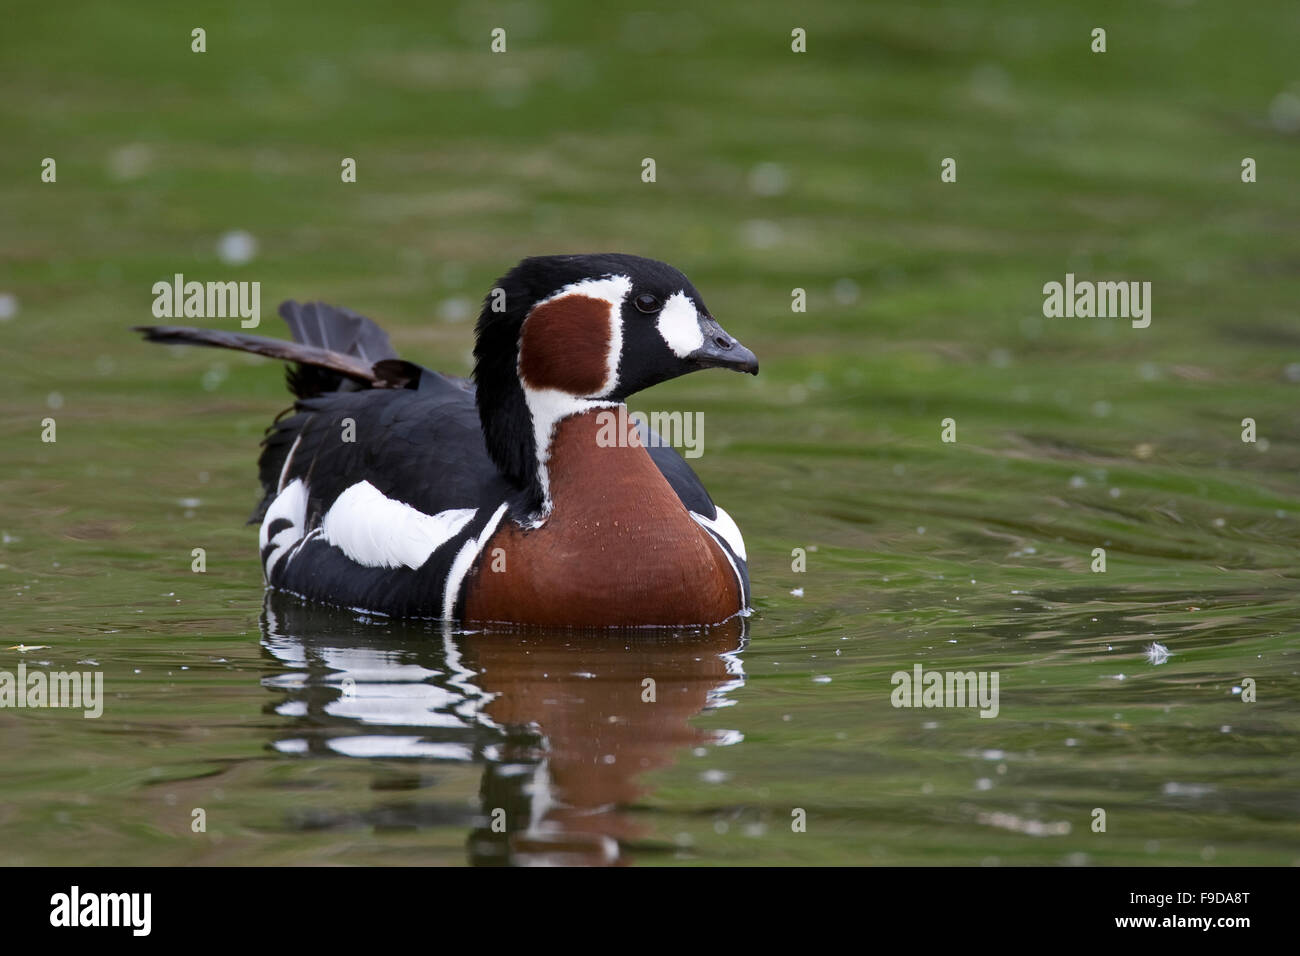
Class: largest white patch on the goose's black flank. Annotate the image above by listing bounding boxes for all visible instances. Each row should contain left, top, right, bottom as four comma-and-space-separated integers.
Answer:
321, 481, 475, 568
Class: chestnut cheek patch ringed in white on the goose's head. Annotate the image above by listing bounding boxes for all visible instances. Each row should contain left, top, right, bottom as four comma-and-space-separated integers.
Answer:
519, 294, 614, 395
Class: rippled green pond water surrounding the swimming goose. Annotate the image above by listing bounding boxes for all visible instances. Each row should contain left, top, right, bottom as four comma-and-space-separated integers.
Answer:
0, 3, 1300, 865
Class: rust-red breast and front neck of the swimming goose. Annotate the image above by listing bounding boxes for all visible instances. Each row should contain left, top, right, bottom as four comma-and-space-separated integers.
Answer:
464, 411, 741, 627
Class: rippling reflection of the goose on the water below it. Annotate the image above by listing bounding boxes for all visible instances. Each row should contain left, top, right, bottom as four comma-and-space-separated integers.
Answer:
261, 592, 746, 865
